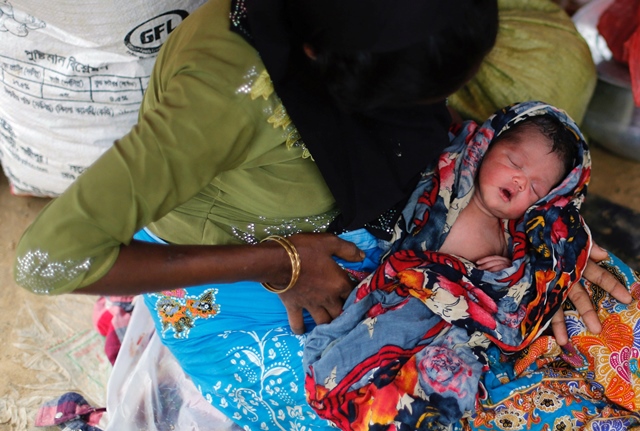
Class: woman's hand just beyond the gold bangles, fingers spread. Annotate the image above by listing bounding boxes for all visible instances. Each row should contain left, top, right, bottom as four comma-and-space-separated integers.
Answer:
272, 233, 364, 334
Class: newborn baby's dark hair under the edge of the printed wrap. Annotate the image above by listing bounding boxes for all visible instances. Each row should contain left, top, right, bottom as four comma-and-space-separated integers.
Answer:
494, 114, 578, 178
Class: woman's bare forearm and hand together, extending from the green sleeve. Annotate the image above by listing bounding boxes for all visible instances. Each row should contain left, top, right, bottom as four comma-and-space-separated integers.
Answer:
75, 233, 365, 334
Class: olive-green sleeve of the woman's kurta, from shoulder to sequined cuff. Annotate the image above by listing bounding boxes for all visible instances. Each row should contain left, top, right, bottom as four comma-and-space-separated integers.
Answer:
14, 73, 253, 294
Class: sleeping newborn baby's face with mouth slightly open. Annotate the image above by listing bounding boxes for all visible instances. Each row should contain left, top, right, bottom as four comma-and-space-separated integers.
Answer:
476, 128, 564, 219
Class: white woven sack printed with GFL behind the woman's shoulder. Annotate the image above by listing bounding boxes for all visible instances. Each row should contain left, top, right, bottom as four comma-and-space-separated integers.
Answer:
0, 0, 205, 196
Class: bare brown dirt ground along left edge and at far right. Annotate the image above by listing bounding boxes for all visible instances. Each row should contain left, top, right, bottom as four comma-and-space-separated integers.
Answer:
0, 145, 640, 431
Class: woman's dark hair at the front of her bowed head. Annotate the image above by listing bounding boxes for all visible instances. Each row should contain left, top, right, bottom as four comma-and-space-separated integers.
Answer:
294, 0, 498, 112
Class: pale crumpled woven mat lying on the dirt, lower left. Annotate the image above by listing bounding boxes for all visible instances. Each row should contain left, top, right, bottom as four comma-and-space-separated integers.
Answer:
0, 295, 111, 431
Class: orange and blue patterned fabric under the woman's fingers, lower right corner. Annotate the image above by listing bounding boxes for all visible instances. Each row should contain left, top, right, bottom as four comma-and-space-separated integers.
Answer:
462, 254, 640, 431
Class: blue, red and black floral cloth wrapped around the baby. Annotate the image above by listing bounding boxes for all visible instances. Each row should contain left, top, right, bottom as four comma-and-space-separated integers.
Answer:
303, 102, 591, 430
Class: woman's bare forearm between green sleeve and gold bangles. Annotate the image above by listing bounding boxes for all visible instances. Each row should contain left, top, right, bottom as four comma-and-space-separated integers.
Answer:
75, 241, 291, 295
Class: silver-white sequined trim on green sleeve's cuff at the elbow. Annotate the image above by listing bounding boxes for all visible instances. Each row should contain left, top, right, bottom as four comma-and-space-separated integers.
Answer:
16, 250, 91, 294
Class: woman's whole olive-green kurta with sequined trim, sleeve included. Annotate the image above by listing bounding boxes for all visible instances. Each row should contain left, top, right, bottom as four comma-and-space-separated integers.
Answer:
15, 0, 335, 294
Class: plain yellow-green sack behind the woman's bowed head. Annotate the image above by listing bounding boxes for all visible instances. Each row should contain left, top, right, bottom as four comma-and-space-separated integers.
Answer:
449, 0, 597, 124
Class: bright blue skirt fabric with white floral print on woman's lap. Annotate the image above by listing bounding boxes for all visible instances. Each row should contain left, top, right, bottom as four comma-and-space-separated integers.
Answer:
135, 229, 382, 431
